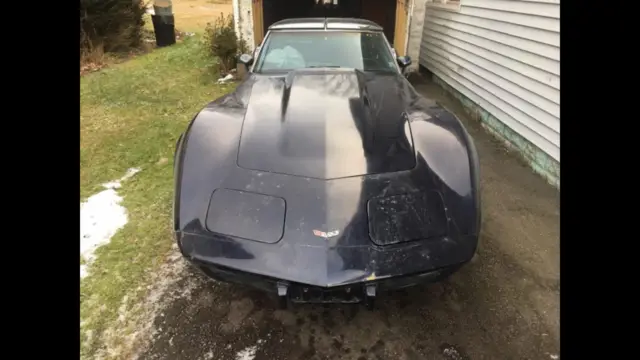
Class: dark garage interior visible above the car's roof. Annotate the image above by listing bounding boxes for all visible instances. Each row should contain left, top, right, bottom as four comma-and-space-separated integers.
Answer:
263, 0, 396, 43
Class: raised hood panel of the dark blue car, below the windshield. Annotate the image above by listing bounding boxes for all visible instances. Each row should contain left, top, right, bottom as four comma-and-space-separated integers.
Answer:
238, 69, 415, 179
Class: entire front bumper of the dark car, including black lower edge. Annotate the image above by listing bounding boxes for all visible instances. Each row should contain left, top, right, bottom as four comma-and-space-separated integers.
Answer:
176, 228, 477, 303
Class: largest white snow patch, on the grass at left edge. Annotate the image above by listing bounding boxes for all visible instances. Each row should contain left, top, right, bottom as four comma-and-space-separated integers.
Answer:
80, 168, 140, 278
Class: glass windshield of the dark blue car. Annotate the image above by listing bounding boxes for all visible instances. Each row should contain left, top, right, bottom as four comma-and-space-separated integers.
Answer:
254, 31, 398, 72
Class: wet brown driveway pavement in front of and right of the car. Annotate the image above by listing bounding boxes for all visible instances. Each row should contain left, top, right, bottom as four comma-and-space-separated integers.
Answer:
140, 76, 560, 360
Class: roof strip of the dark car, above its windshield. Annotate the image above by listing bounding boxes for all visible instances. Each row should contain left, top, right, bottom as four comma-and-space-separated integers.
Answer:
269, 18, 382, 31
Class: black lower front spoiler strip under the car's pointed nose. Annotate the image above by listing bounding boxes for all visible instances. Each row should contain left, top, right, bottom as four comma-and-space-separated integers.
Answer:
189, 259, 464, 306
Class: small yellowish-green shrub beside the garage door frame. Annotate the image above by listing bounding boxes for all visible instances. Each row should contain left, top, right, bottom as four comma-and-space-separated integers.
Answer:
204, 14, 247, 74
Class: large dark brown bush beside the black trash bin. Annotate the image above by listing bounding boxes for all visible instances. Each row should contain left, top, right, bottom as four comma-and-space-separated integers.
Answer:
80, 0, 145, 53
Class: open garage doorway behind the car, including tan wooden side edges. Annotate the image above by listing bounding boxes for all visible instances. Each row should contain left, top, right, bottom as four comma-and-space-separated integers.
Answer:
252, 0, 411, 55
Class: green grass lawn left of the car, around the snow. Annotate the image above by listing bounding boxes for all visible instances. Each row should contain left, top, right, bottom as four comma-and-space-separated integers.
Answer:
80, 36, 234, 358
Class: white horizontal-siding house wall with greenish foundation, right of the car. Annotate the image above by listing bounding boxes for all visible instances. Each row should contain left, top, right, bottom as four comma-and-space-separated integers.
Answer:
418, 0, 560, 186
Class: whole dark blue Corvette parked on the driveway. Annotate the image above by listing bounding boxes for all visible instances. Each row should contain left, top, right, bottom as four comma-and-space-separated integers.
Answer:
174, 19, 480, 305
